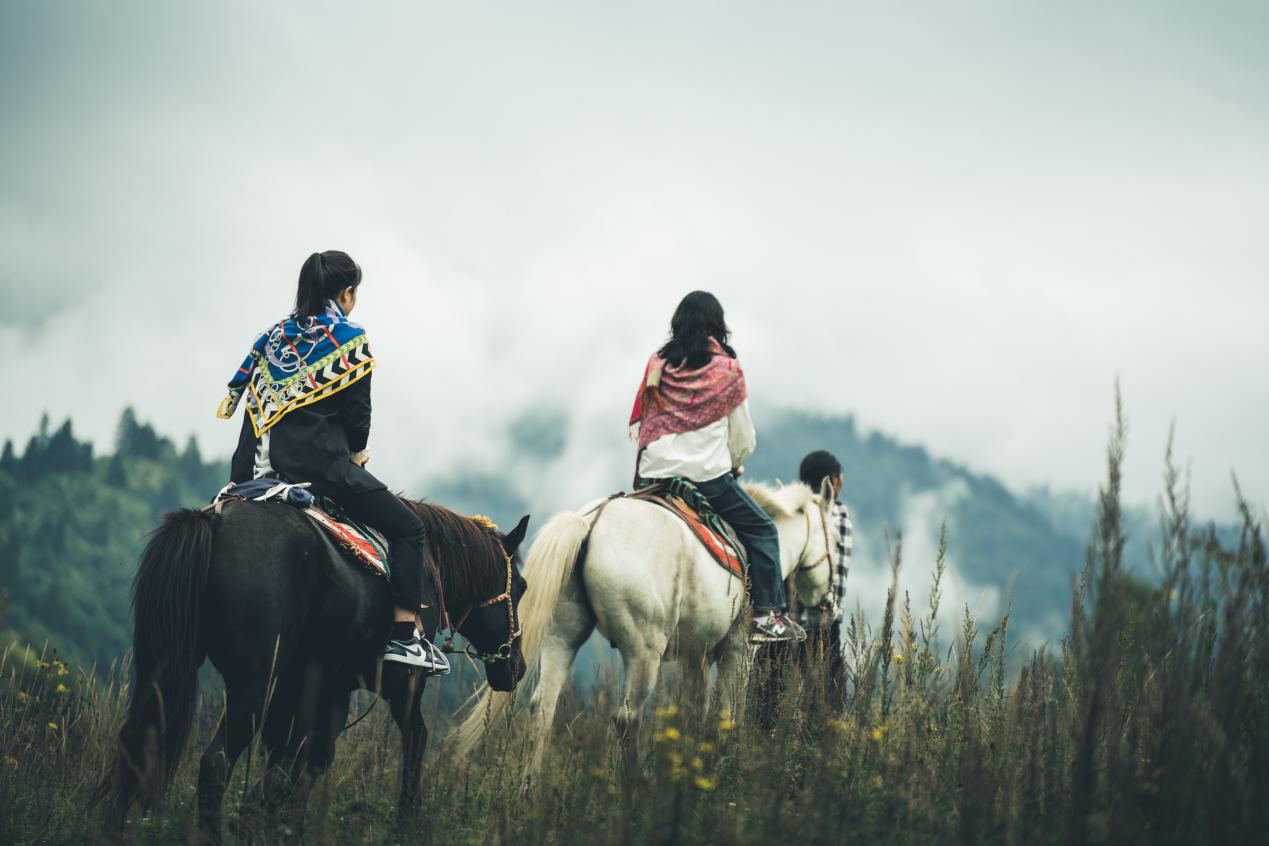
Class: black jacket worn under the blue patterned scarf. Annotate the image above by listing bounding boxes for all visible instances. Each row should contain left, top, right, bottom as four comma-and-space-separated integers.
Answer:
230, 373, 387, 501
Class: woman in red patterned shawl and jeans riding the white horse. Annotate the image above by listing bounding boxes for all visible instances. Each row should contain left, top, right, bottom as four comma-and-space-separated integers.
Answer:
629, 290, 806, 643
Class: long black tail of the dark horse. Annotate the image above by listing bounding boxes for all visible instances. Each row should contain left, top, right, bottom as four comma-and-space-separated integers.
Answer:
102, 509, 214, 823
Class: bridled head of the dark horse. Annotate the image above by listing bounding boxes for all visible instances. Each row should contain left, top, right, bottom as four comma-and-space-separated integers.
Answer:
458, 515, 529, 691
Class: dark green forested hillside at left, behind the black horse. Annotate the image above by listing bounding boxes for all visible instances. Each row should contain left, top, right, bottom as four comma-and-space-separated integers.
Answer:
0, 410, 228, 665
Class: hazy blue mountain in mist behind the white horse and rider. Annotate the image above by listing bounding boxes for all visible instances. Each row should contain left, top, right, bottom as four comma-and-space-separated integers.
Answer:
419, 408, 1121, 639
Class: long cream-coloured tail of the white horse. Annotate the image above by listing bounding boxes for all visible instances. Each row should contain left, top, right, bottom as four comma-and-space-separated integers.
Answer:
457, 511, 591, 755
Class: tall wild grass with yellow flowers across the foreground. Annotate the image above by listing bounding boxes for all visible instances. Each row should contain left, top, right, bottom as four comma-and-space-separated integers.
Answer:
0, 410, 1269, 843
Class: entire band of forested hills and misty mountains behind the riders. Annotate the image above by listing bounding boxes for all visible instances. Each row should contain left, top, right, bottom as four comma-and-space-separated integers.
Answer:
0, 410, 1150, 662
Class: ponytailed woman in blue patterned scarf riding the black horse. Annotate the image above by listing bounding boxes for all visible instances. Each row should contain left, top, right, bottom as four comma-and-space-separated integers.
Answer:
217, 250, 449, 675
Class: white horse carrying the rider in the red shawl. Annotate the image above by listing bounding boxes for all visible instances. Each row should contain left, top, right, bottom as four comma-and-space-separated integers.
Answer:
458, 483, 836, 772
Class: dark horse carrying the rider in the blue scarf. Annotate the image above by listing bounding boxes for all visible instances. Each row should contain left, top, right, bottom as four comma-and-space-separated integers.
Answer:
103, 501, 529, 842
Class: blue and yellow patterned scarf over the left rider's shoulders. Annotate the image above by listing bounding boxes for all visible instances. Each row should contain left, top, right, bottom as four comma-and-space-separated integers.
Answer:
216, 299, 374, 438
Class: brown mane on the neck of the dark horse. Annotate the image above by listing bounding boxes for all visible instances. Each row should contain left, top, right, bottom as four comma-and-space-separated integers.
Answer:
401, 497, 506, 602
